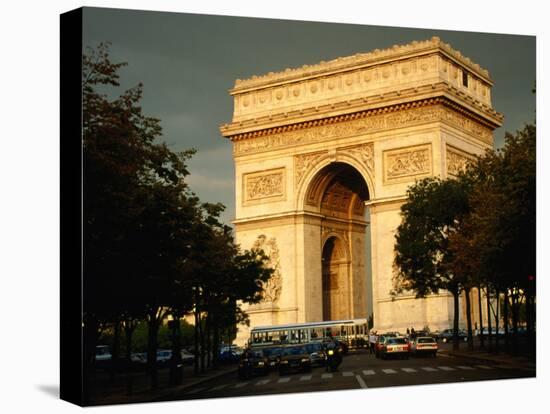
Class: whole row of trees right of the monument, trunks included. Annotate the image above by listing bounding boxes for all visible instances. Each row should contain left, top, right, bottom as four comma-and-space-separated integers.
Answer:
393, 115, 536, 353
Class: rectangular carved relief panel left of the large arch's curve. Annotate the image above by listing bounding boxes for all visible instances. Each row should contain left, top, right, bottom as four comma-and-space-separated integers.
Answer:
247, 168, 285, 203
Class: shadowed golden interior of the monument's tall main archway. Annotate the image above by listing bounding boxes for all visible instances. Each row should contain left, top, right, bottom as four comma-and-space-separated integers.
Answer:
304, 162, 372, 320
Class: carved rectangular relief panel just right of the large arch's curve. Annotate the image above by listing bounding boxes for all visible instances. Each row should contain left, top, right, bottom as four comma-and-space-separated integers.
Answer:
384, 144, 432, 184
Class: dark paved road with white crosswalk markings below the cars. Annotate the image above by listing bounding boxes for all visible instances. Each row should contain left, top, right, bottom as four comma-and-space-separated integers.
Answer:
162, 353, 535, 399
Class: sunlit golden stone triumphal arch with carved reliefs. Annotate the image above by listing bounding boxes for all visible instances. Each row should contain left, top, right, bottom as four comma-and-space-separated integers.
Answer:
220, 38, 502, 343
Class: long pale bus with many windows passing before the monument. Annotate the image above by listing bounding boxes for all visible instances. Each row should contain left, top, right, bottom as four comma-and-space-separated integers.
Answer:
248, 319, 368, 348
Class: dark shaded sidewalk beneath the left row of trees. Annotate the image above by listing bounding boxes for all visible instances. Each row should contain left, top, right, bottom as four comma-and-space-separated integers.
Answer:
91, 365, 237, 406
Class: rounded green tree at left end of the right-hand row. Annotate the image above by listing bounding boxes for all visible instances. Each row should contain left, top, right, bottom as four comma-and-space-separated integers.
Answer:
394, 178, 468, 347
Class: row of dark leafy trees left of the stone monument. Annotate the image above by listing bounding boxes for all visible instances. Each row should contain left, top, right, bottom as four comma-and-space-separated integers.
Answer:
82, 44, 272, 402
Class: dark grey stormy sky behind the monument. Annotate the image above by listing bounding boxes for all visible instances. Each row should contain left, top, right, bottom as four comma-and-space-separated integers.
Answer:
83, 8, 536, 223
